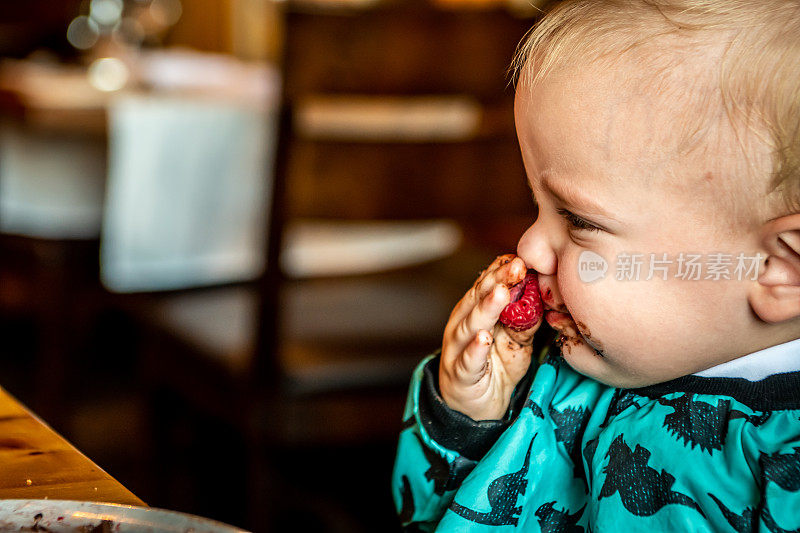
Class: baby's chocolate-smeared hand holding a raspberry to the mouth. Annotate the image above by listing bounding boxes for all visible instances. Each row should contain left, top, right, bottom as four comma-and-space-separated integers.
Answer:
439, 254, 542, 420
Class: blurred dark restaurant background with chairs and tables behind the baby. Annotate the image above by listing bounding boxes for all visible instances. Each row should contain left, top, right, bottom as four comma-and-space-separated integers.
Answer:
0, 0, 545, 532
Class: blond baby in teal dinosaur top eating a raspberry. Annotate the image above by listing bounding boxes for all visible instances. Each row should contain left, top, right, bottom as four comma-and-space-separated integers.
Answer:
393, 0, 800, 533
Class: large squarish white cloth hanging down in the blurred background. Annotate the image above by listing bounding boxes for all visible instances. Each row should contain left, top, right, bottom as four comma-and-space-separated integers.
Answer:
101, 91, 276, 292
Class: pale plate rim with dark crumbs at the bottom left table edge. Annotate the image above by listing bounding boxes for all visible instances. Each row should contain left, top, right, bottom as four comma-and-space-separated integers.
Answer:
0, 500, 246, 533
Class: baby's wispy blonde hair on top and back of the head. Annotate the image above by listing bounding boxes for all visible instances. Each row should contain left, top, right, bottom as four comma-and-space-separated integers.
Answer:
512, 0, 800, 212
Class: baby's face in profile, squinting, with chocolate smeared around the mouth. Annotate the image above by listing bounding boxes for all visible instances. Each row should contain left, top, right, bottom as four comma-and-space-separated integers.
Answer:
515, 61, 765, 387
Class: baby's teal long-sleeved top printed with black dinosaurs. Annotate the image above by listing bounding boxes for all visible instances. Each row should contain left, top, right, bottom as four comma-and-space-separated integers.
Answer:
392, 350, 800, 533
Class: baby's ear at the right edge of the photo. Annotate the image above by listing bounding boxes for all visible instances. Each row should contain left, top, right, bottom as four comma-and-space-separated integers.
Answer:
749, 214, 800, 322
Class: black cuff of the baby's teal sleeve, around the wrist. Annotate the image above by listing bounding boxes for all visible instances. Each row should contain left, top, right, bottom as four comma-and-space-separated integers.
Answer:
419, 357, 537, 461
